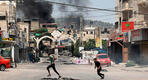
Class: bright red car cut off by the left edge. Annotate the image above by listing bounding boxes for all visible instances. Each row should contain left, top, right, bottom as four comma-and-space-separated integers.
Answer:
0, 56, 10, 71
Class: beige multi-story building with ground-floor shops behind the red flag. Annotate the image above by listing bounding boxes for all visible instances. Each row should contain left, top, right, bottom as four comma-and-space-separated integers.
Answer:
111, 0, 148, 62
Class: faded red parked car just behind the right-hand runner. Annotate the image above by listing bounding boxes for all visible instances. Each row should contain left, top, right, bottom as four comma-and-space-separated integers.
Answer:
96, 54, 111, 66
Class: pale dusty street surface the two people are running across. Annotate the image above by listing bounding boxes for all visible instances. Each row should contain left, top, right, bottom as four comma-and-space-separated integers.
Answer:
0, 62, 148, 80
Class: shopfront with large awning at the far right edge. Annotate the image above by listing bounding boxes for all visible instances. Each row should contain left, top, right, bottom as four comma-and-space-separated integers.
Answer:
131, 28, 148, 64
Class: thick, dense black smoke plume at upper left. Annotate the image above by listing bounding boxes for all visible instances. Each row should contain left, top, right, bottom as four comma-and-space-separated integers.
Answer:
17, 0, 54, 23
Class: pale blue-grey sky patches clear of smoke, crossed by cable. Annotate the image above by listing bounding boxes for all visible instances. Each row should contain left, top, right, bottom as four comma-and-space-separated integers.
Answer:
48, 0, 115, 23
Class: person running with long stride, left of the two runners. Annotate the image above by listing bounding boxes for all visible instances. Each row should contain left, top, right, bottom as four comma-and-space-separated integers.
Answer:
47, 53, 61, 78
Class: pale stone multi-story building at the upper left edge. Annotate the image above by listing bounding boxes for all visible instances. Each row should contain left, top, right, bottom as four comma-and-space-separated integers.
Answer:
0, 0, 16, 39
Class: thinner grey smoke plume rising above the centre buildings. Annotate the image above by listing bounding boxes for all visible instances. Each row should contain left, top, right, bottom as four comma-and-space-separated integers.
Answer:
56, 0, 90, 31
